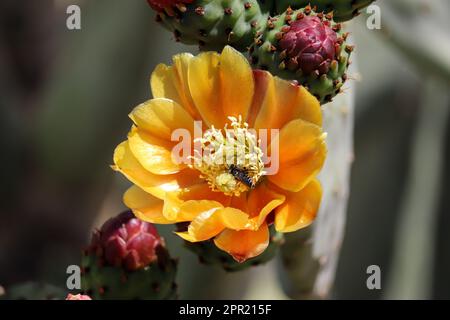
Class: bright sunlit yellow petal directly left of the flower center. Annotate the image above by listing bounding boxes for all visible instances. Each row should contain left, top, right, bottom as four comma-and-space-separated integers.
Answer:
128, 127, 185, 174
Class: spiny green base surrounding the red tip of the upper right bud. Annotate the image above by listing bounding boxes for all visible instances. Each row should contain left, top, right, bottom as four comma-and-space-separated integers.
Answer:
249, 6, 353, 104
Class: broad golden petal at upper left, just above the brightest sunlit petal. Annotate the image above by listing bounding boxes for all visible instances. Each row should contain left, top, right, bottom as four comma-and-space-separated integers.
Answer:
129, 98, 194, 141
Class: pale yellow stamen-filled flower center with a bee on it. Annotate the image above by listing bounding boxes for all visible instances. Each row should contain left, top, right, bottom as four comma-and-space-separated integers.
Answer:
193, 116, 264, 196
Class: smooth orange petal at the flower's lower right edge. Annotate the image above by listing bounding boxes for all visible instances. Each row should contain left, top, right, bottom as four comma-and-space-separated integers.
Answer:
275, 180, 322, 232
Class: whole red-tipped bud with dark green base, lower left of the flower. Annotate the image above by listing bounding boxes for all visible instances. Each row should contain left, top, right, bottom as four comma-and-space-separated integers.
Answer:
81, 211, 177, 300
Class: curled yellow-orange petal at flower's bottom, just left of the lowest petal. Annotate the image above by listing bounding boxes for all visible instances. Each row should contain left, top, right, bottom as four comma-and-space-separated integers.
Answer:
177, 208, 249, 242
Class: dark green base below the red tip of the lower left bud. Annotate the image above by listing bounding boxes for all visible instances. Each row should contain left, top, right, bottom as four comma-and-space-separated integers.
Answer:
81, 246, 177, 300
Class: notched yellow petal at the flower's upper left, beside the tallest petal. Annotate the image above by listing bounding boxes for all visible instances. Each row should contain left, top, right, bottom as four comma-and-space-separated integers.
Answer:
150, 53, 199, 119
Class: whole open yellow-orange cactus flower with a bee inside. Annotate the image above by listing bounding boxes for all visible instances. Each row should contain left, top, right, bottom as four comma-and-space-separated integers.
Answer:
113, 47, 326, 262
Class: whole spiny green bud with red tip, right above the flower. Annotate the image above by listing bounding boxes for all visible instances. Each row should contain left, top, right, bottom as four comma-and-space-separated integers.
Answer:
250, 6, 353, 104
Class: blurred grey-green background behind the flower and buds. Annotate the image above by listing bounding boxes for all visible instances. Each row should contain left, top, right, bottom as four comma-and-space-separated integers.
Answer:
0, 0, 450, 299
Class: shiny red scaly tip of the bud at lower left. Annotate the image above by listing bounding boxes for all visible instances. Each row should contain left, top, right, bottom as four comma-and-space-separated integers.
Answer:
90, 211, 163, 271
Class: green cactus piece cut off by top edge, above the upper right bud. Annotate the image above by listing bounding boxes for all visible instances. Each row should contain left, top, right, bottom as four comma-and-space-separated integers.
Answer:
276, 0, 375, 22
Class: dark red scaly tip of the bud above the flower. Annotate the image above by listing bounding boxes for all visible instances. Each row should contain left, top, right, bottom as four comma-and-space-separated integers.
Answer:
279, 16, 338, 74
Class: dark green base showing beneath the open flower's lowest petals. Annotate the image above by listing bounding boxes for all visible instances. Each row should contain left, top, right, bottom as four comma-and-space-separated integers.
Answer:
185, 230, 284, 272
